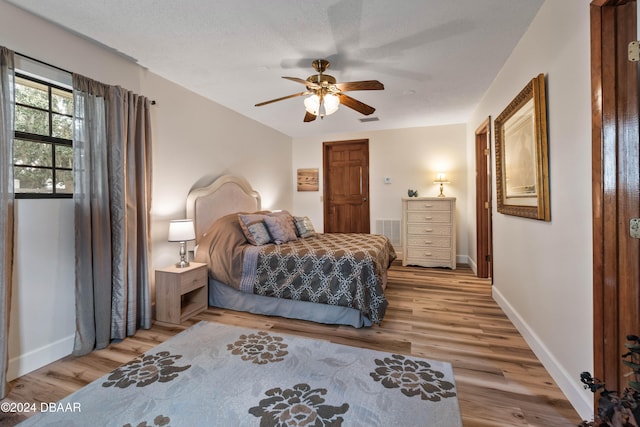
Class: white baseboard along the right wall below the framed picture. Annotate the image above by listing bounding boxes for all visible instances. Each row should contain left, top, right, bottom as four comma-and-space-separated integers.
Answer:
492, 287, 594, 420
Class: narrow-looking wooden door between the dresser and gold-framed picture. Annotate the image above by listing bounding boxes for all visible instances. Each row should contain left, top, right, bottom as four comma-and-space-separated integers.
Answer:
476, 118, 493, 278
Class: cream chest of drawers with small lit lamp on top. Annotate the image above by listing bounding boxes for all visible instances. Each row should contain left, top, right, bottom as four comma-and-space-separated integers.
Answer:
402, 197, 456, 269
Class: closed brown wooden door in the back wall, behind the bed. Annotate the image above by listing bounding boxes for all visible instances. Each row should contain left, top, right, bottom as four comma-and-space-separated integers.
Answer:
323, 139, 370, 233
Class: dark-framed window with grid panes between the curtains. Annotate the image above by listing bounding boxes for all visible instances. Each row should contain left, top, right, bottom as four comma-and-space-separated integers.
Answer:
13, 73, 73, 198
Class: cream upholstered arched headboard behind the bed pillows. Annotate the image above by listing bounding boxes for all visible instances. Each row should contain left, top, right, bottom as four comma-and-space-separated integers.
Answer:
187, 175, 261, 244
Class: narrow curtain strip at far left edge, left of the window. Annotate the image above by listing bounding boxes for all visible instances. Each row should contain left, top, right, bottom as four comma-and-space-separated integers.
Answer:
0, 46, 15, 399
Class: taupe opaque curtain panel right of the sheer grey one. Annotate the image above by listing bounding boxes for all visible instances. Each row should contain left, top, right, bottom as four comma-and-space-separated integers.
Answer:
108, 86, 151, 339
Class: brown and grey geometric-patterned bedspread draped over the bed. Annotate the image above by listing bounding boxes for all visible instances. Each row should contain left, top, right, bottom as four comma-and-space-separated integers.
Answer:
240, 233, 396, 323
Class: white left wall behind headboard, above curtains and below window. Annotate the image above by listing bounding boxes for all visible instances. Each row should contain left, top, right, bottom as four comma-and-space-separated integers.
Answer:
0, 2, 293, 379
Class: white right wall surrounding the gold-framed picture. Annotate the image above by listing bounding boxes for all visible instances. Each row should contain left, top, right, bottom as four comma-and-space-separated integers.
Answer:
467, 0, 593, 419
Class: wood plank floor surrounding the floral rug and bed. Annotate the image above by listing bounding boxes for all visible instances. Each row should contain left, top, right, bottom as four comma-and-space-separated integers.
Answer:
0, 263, 580, 427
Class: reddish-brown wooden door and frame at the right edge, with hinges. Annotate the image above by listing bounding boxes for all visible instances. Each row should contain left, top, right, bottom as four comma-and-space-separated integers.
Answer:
591, 0, 640, 400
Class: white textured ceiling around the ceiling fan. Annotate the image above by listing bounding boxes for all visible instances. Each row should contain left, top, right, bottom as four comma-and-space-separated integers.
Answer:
5, 0, 543, 137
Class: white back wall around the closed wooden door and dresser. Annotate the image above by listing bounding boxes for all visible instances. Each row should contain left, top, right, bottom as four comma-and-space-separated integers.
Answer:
292, 124, 469, 264
